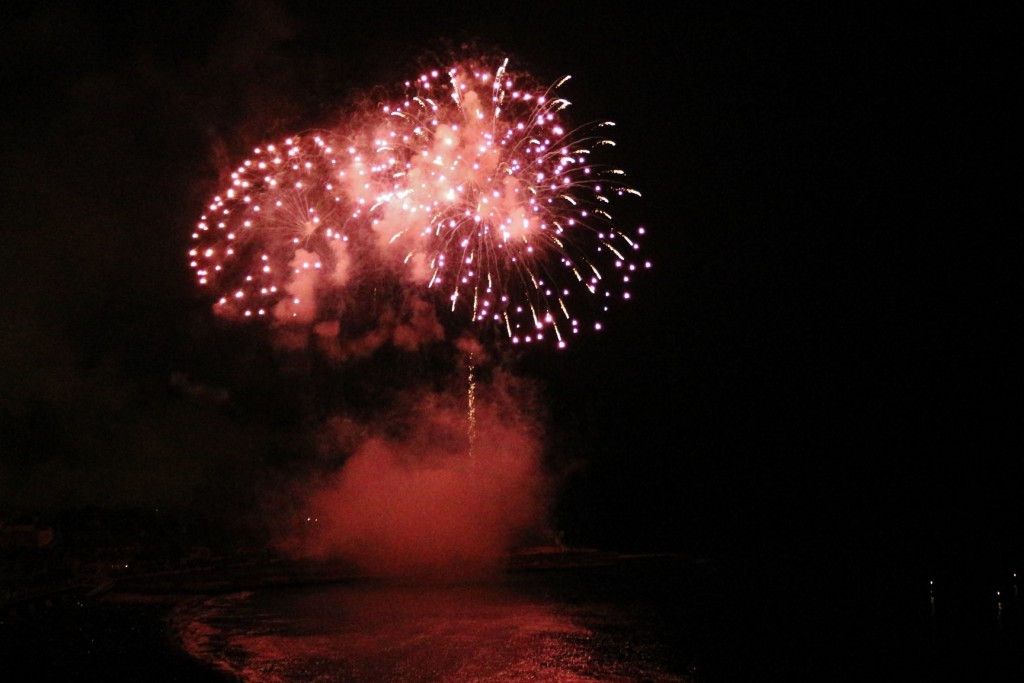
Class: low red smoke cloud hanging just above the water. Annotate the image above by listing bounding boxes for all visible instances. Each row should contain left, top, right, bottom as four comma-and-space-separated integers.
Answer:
276, 374, 550, 579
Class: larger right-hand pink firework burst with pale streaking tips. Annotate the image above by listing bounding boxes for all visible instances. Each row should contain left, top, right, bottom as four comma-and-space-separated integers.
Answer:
360, 59, 649, 346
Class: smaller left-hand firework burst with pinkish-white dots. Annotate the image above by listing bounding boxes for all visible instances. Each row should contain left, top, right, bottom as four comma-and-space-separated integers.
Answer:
188, 133, 356, 323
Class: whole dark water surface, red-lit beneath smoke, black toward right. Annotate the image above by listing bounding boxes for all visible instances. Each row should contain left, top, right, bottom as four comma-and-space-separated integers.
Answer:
169, 556, 1024, 683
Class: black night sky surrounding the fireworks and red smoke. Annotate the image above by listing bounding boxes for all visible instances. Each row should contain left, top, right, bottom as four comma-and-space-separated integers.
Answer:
0, 1, 1024, 565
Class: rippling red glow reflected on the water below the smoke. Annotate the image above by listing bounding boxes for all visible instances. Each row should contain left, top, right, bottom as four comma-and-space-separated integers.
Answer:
176, 557, 687, 683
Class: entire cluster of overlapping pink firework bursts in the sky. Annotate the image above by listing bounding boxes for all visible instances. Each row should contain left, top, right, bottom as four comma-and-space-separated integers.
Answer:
189, 58, 649, 347
